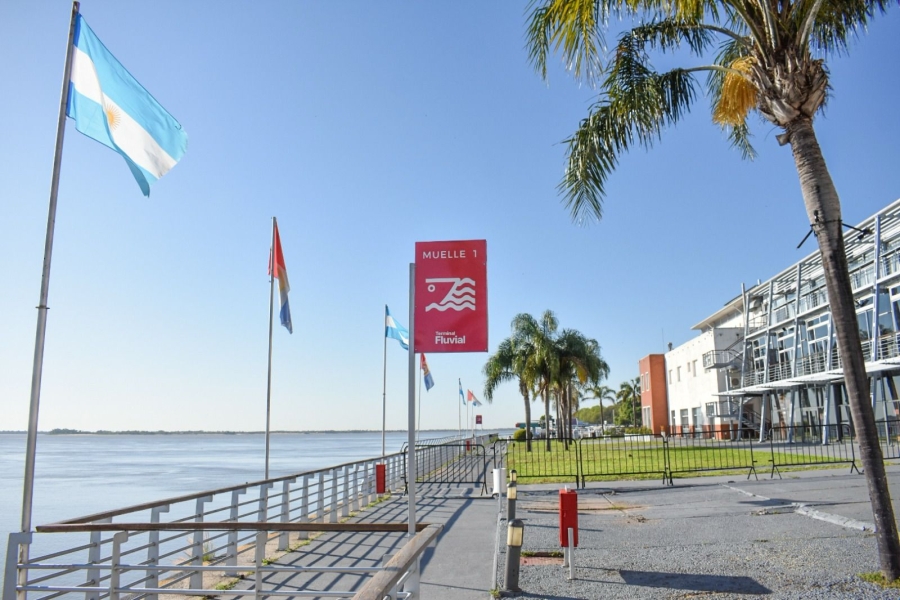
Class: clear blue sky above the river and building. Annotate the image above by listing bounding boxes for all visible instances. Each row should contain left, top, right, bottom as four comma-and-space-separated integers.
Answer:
0, 0, 900, 431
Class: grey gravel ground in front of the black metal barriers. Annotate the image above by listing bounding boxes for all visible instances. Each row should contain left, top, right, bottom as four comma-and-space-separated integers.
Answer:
499, 475, 900, 599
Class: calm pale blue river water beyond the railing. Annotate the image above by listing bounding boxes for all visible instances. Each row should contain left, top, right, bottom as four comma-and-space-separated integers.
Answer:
0, 430, 500, 584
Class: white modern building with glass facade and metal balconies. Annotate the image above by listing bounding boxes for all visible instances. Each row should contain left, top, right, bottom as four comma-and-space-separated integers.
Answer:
665, 200, 900, 440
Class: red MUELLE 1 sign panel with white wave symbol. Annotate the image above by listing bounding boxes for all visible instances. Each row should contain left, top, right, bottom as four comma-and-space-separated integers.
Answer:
414, 240, 488, 352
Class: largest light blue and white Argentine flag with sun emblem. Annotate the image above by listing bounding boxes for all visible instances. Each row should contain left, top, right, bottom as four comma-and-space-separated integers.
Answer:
66, 14, 187, 196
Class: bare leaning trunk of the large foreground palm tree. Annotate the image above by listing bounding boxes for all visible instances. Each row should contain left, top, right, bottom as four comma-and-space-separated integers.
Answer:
787, 118, 900, 581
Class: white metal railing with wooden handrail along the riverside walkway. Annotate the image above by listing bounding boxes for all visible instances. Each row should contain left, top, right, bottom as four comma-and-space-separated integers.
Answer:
3, 434, 502, 600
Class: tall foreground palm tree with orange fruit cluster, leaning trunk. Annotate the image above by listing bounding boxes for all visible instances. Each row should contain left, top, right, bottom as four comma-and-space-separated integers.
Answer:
527, 0, 900, 581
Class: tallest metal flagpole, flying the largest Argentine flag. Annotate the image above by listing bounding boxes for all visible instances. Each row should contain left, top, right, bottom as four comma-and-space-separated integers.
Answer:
18, 2, 79, 598
